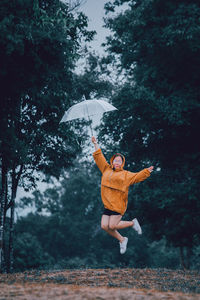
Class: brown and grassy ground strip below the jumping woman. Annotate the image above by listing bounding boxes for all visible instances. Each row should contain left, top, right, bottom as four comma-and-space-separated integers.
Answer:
0, 269, 200, 300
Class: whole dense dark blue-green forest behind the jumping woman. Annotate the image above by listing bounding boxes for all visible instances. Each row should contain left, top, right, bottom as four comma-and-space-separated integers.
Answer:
0, 0, 200, 272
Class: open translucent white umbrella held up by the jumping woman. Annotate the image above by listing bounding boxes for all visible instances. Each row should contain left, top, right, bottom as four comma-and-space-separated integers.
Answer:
60, 96, 117, 135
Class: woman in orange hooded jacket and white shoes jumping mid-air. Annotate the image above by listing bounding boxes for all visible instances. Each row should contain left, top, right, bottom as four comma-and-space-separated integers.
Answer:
92, 136, 154, 254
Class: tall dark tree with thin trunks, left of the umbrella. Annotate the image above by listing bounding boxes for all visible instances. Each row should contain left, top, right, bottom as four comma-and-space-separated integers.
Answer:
0, 0, 93, 270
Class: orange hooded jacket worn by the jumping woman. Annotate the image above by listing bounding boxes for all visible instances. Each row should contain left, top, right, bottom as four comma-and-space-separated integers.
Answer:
93, 149, 150, 215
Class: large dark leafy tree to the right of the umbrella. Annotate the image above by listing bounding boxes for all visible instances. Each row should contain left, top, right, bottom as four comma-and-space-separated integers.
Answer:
101, 0, 200, 268
